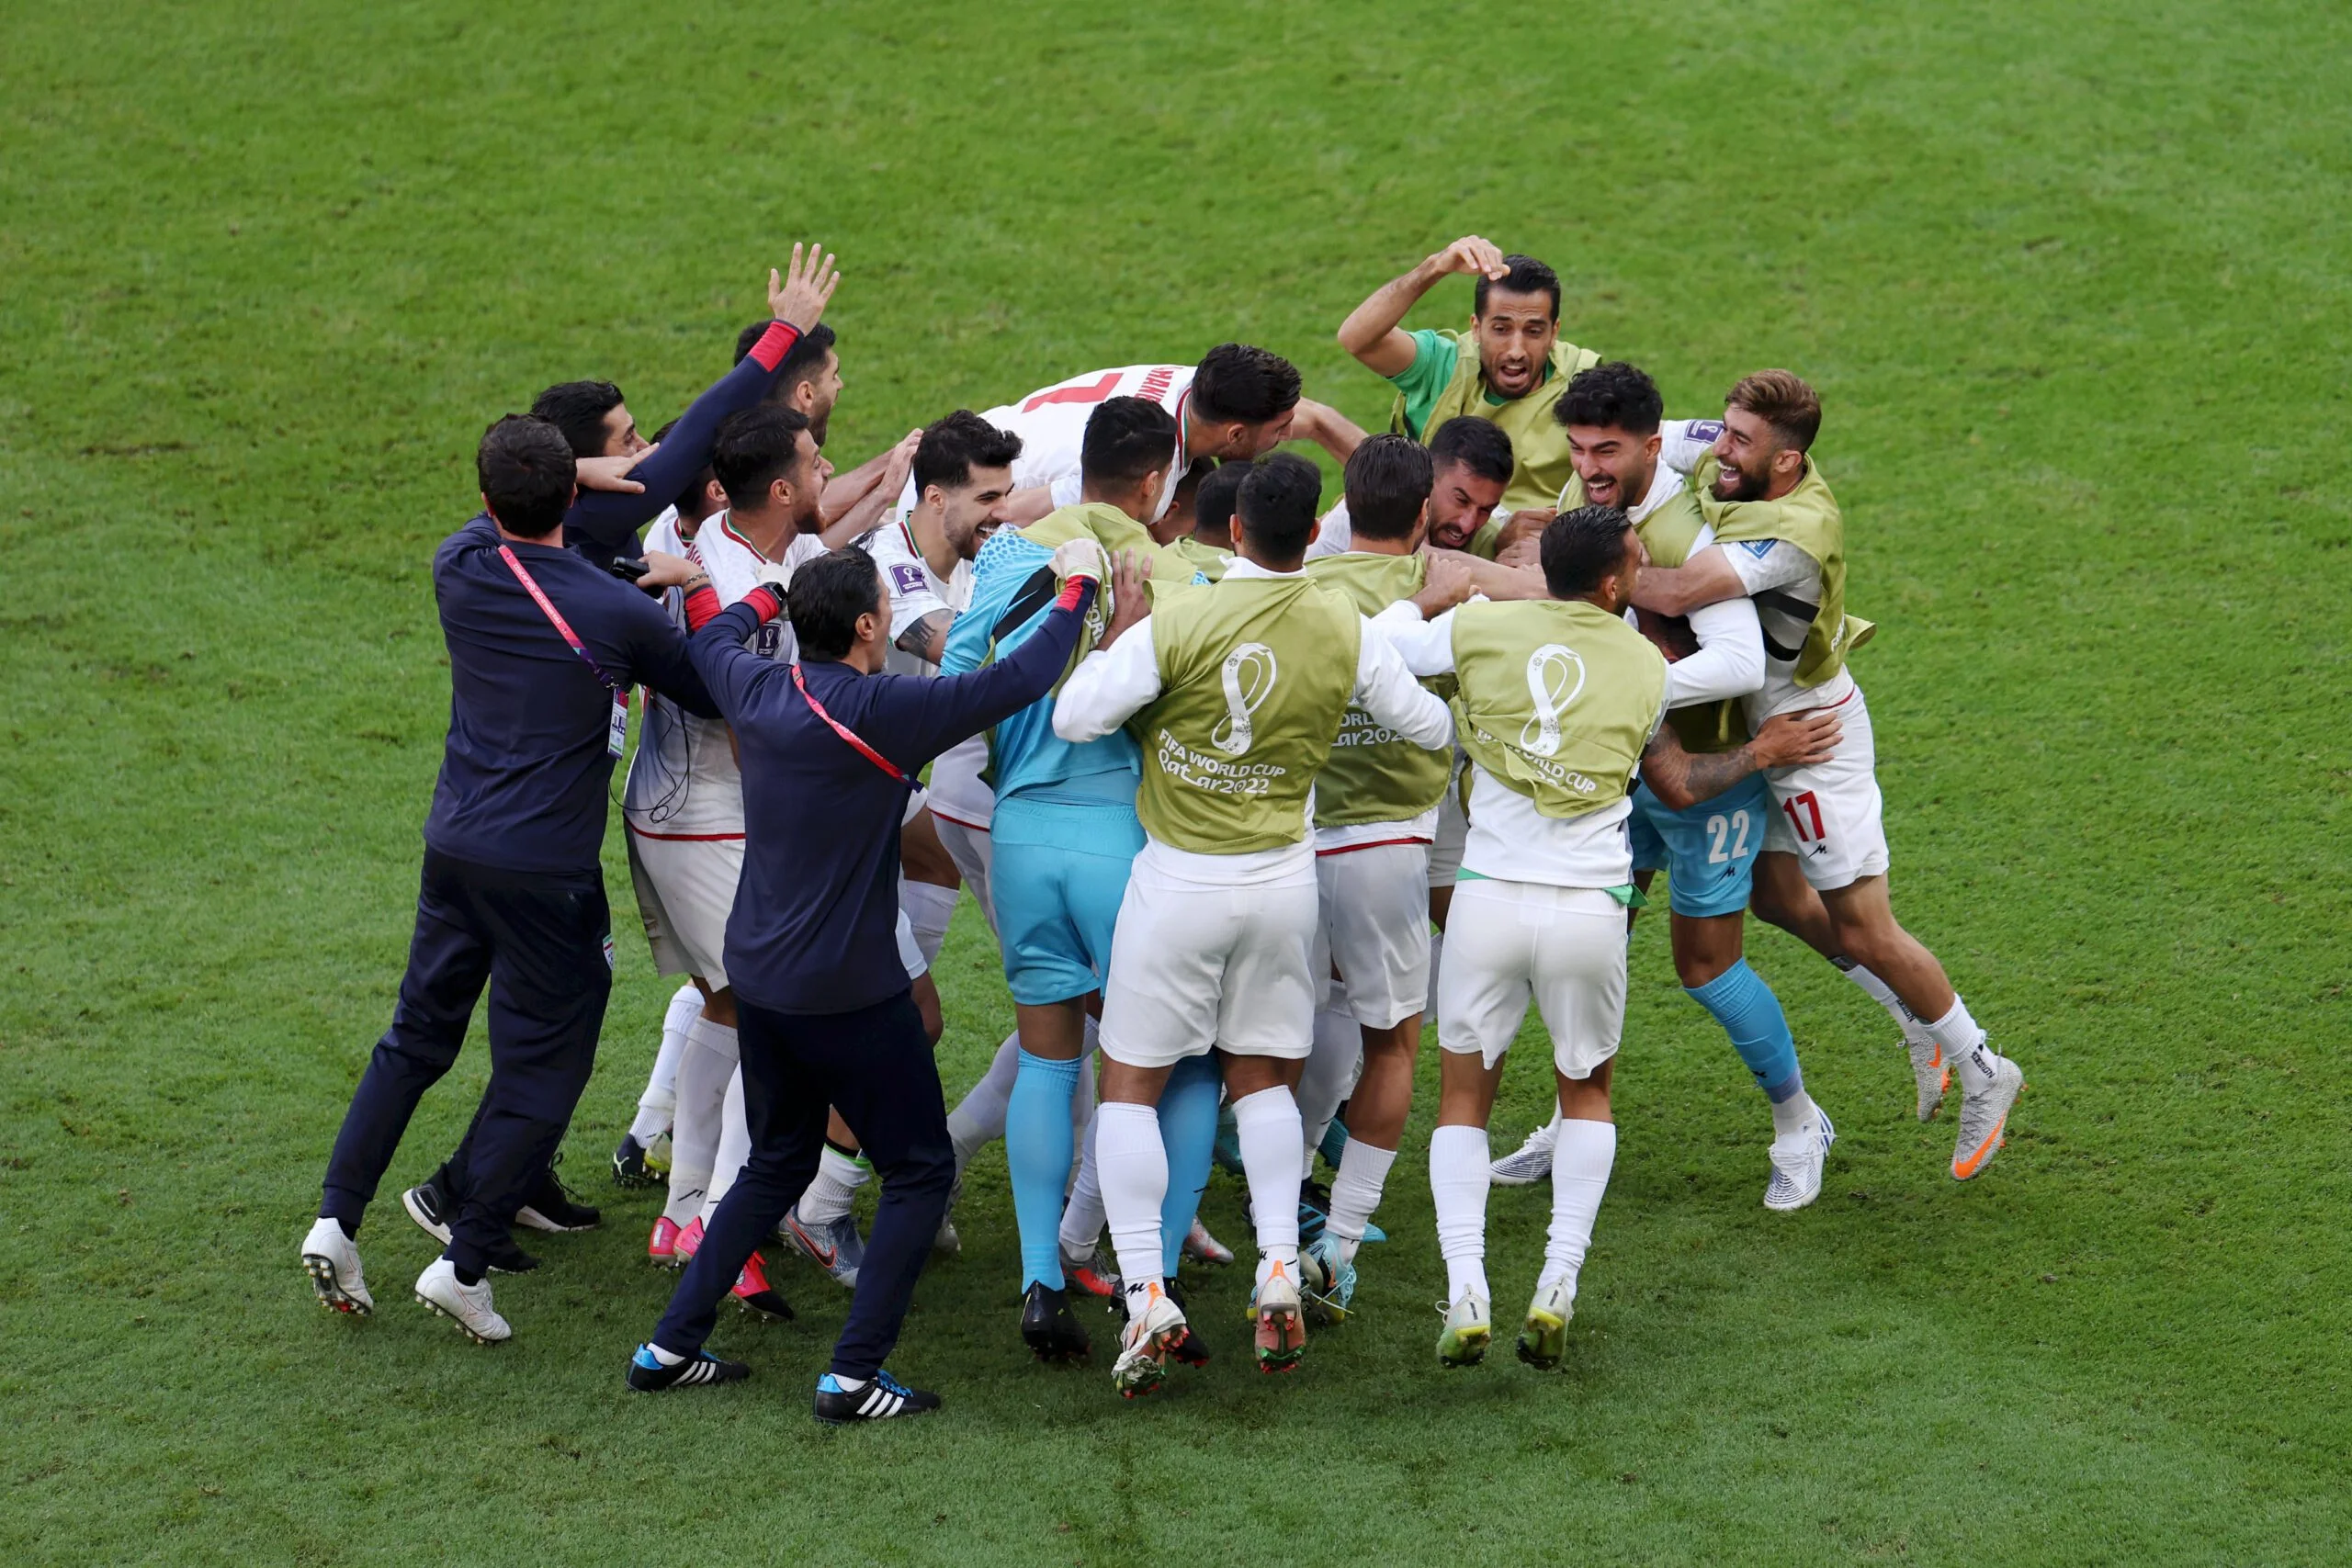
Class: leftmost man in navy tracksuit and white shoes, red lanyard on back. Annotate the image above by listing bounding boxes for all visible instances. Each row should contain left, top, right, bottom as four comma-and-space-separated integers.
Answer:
301, 413, 718, 1345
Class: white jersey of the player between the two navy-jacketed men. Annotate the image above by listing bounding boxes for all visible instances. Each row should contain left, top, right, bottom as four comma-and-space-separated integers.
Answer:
621, 513, 826, 840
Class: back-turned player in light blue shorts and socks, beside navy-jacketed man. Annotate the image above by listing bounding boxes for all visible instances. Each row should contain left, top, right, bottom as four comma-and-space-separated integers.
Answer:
941, 398, 1216, 1359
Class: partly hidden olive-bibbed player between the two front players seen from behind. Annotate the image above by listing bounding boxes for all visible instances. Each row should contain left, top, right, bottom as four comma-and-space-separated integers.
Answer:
1301, 425, 1491, 1312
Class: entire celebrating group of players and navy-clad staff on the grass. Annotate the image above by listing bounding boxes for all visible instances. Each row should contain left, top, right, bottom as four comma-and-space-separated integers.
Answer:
303, 235, 2023, 1422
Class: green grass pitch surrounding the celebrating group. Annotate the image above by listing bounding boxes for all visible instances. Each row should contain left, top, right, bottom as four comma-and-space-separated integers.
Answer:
0, 0, 2352, 1568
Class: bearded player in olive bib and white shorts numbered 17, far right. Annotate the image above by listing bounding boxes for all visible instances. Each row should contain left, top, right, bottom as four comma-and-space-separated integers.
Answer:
1634, 369, 2025, 1180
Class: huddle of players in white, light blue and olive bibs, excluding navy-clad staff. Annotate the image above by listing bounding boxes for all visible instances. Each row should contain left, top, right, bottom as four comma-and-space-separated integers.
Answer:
299, 235, 2023, 1413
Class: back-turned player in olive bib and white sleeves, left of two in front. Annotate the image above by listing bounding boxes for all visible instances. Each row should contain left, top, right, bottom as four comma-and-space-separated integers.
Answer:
1054, 454, 1465, 1396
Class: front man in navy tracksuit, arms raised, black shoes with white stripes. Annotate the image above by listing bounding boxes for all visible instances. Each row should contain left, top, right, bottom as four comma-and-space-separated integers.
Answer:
628, 541, 1103, 1422
